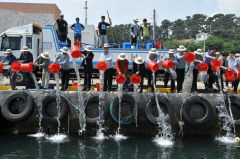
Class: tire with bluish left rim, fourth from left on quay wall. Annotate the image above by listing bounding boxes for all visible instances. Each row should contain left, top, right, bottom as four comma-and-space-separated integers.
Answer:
110, 94, 135, 125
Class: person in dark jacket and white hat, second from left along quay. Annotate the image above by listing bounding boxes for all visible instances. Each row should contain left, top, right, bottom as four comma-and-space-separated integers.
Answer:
18, 46, 35, 89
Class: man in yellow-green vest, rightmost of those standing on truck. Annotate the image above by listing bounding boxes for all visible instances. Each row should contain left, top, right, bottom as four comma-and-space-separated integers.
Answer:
140, 19, 153, 44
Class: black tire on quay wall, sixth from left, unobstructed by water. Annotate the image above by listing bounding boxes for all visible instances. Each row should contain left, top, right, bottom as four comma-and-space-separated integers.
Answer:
182, 96, 213, 126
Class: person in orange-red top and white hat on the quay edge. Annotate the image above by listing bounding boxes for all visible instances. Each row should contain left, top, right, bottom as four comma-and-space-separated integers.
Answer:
116, 53, 129, 90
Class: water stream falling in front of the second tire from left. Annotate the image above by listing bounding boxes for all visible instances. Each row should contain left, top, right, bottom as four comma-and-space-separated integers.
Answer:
54, 73, 61, 134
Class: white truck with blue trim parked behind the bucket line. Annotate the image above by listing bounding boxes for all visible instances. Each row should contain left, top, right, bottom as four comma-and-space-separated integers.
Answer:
0, 23, 168, 83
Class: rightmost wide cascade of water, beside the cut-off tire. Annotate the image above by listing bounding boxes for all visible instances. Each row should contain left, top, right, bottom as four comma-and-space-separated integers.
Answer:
216, 71, 235, 141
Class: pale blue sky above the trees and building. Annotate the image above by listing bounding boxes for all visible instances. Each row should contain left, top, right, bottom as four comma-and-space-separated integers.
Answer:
0, 0, 240, 26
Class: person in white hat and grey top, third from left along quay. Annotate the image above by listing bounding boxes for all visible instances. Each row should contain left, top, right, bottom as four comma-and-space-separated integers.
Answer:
33, 52, 50, 89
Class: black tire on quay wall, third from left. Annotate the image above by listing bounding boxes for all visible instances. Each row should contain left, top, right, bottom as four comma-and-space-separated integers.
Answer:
84, 96, 108, 125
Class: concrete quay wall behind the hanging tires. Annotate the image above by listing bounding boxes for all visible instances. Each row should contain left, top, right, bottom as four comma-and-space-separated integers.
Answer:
0, 91, 240, 136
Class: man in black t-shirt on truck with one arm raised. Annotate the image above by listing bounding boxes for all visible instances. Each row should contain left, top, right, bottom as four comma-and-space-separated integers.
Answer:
97, 15, 112, 48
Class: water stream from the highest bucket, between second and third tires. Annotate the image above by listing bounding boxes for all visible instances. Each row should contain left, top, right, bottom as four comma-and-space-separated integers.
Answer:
73, 58, 86, 135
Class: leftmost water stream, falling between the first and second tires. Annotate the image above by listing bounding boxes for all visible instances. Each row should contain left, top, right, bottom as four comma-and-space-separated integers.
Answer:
30, 72, 43, 134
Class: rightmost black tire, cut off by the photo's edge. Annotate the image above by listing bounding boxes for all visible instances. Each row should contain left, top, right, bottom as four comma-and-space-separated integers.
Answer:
226, 96, 240, 127
